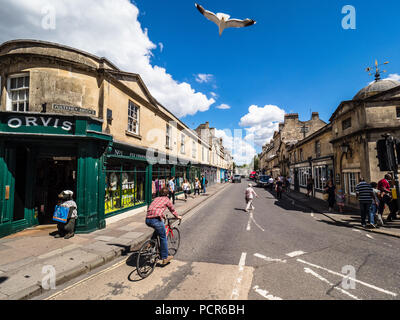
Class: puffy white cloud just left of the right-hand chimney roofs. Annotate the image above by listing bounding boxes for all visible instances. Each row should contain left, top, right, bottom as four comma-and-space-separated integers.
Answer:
239, 105, 285, 147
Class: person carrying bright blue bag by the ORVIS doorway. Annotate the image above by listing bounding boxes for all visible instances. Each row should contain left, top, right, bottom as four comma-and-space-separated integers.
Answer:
54, 190, 78, 239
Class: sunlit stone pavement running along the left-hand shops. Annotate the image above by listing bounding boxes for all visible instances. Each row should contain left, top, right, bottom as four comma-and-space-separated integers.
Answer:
0, 184, 229, 300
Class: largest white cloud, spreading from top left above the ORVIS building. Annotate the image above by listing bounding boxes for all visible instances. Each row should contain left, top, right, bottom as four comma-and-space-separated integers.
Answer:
0, 0, 215, 117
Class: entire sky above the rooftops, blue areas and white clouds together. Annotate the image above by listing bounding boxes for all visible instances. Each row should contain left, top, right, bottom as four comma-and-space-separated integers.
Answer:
0, 0, 400, 164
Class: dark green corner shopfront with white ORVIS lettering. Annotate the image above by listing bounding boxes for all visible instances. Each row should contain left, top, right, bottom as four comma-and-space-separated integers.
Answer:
0, 112, 112, 237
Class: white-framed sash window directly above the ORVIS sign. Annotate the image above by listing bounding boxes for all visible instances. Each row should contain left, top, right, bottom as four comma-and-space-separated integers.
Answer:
7, 73, 29, 112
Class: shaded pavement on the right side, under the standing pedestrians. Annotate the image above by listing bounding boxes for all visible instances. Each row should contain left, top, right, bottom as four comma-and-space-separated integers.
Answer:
283, 190, 400, 238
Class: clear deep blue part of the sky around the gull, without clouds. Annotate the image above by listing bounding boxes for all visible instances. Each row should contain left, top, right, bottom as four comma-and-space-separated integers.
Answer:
136, 0, 400, 134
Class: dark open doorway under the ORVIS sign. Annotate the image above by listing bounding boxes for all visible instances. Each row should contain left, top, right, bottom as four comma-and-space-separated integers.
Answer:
34, 157, 77, 225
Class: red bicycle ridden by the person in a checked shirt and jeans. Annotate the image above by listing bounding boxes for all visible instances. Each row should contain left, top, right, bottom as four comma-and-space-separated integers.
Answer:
136, 218, 182, 279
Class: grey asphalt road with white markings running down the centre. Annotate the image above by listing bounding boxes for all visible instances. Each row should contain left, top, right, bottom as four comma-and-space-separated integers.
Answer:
37, 181, 400, 300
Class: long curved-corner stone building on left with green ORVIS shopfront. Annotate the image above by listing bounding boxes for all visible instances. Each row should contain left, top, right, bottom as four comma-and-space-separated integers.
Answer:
0, 40, 230, 237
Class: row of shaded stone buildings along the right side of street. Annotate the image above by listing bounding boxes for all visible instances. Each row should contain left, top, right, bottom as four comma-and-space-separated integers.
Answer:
259, 77, 400, 206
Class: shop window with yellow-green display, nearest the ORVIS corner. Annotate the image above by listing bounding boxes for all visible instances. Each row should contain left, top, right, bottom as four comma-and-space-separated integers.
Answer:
105, 165, 146, 215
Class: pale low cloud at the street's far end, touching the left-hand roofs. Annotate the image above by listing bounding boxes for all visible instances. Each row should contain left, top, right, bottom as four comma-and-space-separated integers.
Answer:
215, 129, 257, 165
